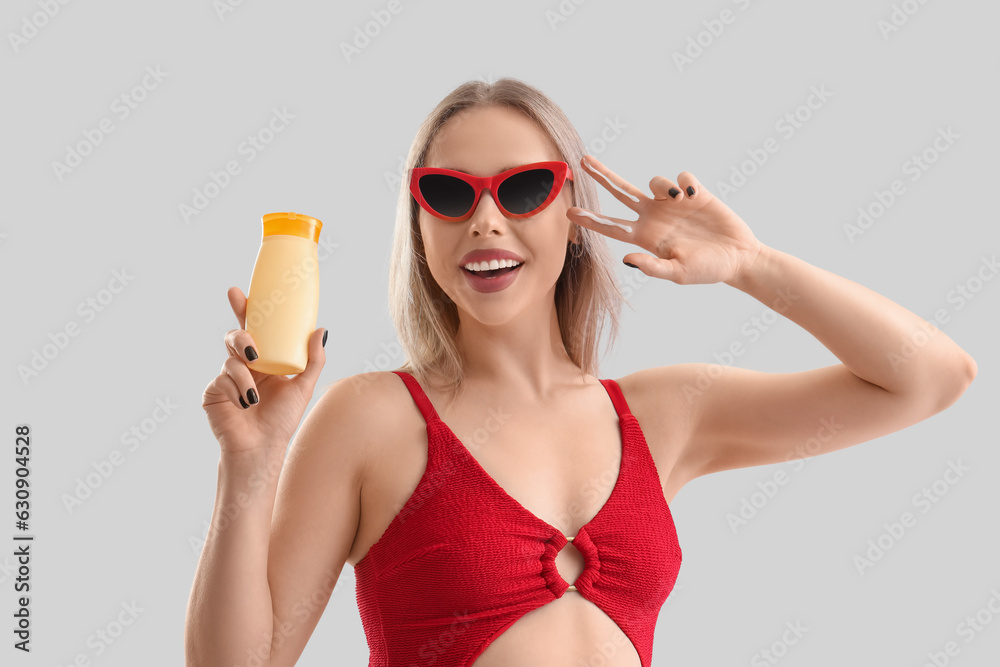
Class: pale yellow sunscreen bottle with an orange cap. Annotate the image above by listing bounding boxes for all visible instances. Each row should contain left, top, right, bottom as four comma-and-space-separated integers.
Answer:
246, 213, 323, 375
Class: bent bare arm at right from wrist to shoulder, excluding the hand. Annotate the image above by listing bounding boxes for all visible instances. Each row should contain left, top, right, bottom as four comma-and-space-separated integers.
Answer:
633, 246, 976, 480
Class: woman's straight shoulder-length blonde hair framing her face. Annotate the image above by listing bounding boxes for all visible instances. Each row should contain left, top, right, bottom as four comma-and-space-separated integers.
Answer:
389, 77, 624, 400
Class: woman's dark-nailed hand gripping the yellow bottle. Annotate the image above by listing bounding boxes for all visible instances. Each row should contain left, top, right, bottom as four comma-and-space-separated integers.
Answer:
202, 287, 326, 457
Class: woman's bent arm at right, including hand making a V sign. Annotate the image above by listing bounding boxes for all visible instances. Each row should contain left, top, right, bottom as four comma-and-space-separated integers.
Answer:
567, 156, 976, 488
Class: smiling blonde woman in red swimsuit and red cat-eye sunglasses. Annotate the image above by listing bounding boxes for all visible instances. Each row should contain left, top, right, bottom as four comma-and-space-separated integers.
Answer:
186, 79, 976, 667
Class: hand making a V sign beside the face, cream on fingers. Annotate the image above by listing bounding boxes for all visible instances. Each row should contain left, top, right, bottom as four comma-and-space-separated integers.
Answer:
567, 155, 763, 285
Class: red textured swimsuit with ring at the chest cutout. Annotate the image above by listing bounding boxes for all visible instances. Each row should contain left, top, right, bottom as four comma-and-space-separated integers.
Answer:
354, 371, 681, 667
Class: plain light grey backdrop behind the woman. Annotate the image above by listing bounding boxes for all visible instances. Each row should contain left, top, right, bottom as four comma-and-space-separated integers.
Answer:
0, 0, 1000, 667
